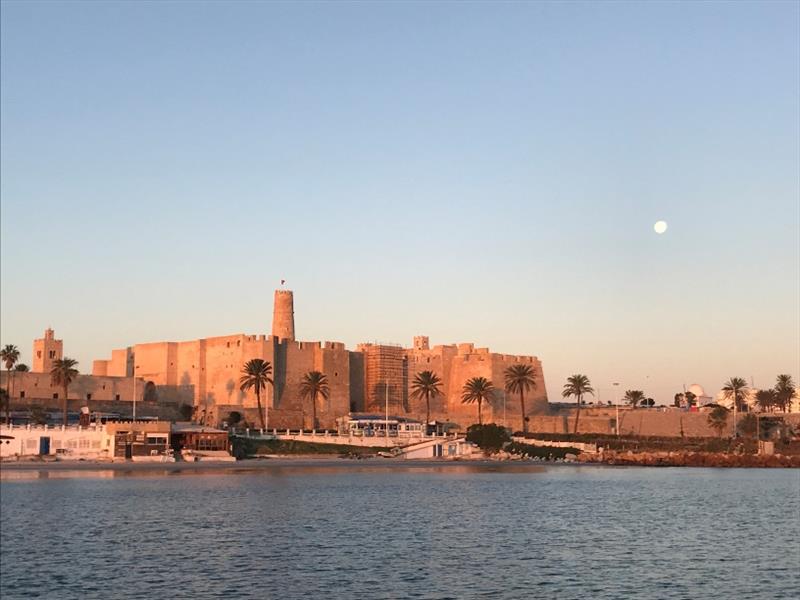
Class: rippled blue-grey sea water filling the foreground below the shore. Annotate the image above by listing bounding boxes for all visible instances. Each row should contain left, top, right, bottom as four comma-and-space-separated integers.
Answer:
0, 463, 800, 600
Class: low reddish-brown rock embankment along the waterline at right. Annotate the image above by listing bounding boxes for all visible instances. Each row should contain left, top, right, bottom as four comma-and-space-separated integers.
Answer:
578, 450, 800, 468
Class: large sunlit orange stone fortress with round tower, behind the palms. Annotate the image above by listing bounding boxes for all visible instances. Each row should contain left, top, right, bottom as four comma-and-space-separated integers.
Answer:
87, 289, 547, 428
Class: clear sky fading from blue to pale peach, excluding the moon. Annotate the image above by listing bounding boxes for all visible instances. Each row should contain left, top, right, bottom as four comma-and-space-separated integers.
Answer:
0, 1, 800, 403
